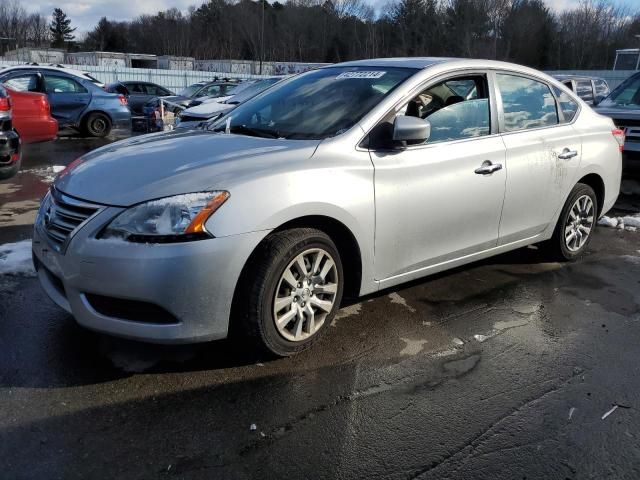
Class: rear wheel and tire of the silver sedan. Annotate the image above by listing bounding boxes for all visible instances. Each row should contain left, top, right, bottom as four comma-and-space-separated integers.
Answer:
546, 183, 598, 261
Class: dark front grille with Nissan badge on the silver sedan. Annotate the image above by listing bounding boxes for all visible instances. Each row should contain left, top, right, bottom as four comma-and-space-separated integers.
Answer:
41, 188, 100, 252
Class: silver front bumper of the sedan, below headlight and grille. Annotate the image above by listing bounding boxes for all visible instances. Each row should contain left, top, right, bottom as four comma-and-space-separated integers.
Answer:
33, 207, 264, 343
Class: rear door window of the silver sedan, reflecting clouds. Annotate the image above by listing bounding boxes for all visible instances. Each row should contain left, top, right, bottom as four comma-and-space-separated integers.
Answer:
496, 73, 559, 132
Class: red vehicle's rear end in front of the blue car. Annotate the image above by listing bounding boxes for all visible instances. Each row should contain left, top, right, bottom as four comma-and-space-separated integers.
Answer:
7, 88, 58, 143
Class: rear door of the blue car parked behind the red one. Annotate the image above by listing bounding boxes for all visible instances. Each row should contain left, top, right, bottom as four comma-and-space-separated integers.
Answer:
43, 73, 91, 126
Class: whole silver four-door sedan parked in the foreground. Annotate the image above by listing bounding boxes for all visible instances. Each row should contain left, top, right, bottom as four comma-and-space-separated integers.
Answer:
33, 58, 624, 355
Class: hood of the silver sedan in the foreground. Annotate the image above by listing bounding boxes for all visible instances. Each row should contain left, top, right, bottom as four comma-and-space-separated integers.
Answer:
54, 130, 320, 207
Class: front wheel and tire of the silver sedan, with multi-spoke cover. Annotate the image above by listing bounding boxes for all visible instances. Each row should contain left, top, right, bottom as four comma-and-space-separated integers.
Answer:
234, 228, 344, 357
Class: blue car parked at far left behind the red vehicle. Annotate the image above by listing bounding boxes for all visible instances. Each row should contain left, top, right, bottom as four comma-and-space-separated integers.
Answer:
0, 65, 131, 137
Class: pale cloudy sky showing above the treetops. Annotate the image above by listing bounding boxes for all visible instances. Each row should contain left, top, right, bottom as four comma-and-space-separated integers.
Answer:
23, 0, 638, 33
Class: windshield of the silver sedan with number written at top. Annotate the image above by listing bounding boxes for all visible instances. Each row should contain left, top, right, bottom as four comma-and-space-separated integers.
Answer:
211, 67, 417, 140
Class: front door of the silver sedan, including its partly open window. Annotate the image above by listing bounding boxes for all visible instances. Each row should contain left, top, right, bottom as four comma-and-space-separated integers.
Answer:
370, 75, 507, 287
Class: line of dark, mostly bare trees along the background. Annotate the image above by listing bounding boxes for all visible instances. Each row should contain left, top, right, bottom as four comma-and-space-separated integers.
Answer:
0, 0, 640, 69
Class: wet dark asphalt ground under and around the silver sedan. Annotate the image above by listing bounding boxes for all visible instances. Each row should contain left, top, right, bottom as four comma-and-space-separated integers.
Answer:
0, 132, 640, 479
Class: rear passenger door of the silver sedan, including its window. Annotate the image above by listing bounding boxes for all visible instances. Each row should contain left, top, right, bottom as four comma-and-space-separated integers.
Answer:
495, 72, 582, 245
